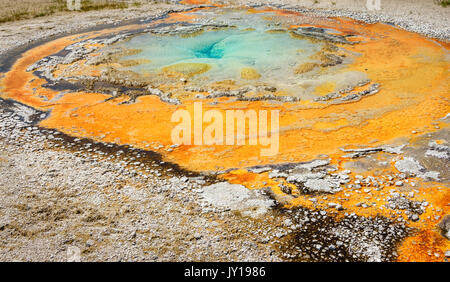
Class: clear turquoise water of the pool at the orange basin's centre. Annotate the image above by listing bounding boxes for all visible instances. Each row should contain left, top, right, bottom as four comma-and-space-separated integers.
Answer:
116, 23, 320, 82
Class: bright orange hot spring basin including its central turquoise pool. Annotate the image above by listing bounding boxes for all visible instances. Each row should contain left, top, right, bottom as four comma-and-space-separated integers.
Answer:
1, 4, 449, 260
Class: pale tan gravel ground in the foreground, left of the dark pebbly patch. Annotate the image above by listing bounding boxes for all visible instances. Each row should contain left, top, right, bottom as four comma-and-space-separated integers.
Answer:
0, 100, 285, 261
